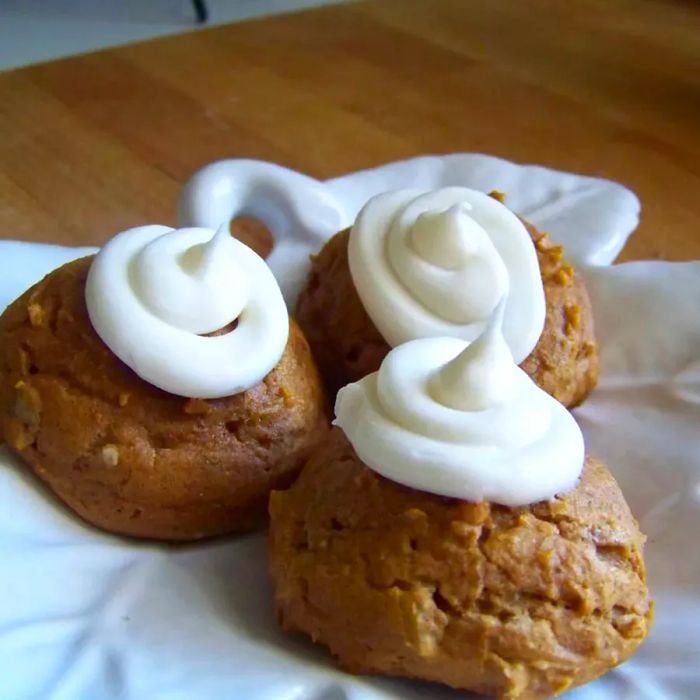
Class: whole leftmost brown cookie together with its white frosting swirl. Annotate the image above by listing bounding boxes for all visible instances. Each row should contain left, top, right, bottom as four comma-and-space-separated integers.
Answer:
0, 226, 327, 540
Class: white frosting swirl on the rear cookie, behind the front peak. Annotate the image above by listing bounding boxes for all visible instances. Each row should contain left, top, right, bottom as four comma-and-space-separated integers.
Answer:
348, 187, 545, 363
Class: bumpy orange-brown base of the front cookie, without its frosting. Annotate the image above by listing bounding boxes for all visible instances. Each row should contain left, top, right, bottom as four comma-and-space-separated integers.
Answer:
270, 430, 653, 699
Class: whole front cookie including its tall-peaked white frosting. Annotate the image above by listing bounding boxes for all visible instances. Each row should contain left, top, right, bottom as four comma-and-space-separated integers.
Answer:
269, 306, 653, 700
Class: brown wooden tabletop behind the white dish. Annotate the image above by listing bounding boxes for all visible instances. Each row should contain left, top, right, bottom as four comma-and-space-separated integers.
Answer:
0, 0, 700, 259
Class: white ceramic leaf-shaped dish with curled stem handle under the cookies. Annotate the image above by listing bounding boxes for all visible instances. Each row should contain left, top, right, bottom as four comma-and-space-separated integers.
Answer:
0, 155, 700, 700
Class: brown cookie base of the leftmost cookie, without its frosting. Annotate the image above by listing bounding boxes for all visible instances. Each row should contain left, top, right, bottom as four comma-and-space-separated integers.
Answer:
0, 258, 328, 540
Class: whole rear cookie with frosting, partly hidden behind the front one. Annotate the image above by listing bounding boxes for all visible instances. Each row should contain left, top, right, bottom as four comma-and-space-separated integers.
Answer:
296, 187, 598, 407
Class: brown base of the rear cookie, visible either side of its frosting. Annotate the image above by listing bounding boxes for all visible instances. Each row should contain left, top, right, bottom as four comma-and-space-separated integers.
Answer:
296, 202, 598, 407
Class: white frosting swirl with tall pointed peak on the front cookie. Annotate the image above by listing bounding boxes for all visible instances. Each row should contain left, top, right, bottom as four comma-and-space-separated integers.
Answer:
335, 303, 584, 506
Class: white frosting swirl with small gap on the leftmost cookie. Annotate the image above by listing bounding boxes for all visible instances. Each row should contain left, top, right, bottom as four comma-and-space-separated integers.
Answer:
85, 226, 289, 398
